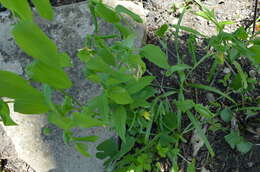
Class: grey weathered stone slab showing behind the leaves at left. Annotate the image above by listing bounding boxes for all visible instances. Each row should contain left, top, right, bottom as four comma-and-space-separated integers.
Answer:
0, 2, 145, 172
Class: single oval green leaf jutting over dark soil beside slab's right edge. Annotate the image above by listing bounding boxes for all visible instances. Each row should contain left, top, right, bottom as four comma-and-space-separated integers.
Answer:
141, 44, 170, 69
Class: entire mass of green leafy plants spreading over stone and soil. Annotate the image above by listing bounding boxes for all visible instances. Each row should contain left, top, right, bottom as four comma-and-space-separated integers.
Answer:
0, 0, 260, 172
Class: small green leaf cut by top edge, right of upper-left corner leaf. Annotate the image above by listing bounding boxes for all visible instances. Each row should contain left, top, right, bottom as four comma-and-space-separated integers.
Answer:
32, 0, 54, 20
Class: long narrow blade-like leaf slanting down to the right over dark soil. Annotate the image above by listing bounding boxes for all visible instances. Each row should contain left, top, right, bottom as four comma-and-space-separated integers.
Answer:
187, 111, 215, 156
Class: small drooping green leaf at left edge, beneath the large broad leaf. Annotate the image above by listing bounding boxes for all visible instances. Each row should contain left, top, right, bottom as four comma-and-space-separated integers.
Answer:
0, 98, 17, 126
